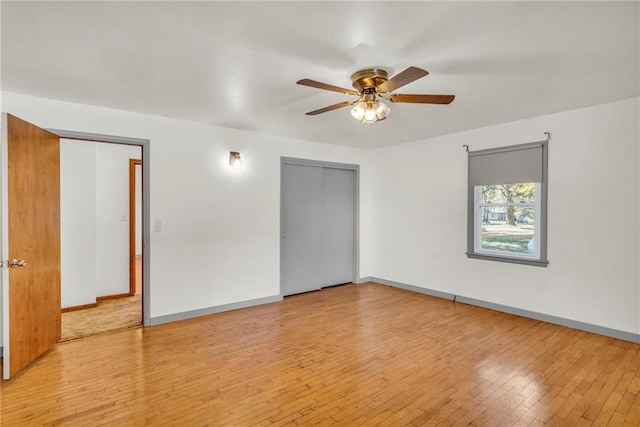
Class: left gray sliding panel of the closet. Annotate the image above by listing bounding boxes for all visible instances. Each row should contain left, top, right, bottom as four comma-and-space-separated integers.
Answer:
280, 164, 322, 295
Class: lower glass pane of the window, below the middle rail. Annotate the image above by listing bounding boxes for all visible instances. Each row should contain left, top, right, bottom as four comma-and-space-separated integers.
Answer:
481, 205, 535, 254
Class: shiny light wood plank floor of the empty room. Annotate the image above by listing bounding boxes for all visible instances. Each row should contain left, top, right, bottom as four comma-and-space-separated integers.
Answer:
1, 284, 640, 426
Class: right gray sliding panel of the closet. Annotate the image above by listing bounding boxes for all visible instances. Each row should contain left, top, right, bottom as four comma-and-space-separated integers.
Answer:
322, 168, 356, 287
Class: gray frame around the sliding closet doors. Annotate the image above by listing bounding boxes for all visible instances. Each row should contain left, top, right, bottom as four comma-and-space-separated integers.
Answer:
279, 156, 360, 296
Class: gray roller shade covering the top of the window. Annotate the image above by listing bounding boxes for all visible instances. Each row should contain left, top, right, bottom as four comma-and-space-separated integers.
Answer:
469, 142, 544, 186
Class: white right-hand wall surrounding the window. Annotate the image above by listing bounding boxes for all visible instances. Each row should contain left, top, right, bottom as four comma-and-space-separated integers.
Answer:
367, 98, 640, 333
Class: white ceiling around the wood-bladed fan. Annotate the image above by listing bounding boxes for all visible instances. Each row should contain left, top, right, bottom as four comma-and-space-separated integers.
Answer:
1, 1, 640, 148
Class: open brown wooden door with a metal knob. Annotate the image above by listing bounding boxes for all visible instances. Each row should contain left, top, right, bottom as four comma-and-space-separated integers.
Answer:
4, 115, 61, 378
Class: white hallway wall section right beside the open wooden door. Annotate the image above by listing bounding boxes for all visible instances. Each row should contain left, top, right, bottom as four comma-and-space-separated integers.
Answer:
60, 139, 96, 307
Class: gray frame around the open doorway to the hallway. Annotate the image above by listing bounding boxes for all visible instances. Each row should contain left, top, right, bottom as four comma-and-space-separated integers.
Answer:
47, 128, 151, 327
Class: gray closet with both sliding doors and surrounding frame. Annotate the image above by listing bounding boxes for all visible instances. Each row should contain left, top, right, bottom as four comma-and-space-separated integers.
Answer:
281, 163, 357, 295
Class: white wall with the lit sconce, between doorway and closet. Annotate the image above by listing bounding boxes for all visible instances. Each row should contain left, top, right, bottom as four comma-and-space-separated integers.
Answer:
2, 92, 367, 332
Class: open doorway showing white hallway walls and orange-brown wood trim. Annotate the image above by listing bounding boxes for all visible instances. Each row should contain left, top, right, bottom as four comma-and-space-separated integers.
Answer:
60, 138, 143, 341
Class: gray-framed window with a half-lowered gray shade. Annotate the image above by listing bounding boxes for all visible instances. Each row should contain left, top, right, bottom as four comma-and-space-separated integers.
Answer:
467, 141, 548, 266
